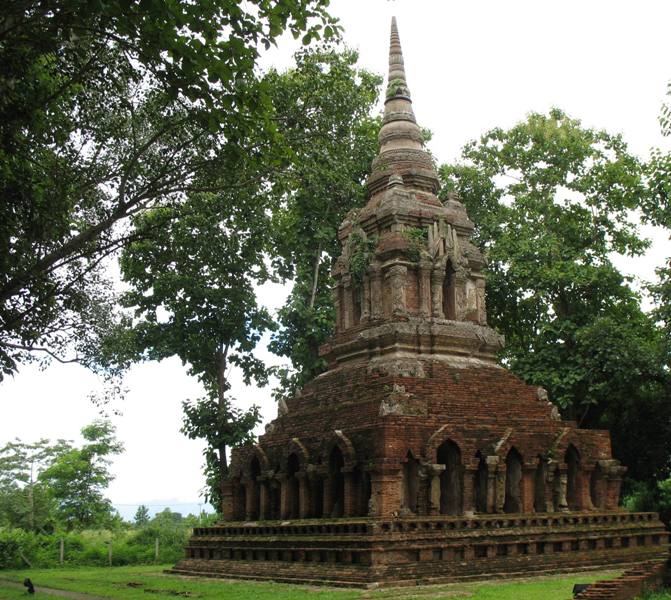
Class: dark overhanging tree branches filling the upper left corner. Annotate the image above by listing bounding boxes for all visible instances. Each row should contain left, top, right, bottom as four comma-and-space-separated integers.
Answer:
0, 0, 338, 378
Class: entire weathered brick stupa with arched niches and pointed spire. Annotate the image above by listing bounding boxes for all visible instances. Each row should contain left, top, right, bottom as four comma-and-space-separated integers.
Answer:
172, 20, 668, 586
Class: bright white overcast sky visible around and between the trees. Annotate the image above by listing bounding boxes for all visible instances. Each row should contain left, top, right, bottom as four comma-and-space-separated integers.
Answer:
0, 0, 671, 513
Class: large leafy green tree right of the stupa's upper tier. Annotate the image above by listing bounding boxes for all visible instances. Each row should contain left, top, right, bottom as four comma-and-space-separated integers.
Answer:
441, 109, 671, 478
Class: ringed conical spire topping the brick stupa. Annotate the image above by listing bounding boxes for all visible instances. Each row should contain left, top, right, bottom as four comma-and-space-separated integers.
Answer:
368, 17, 438, 195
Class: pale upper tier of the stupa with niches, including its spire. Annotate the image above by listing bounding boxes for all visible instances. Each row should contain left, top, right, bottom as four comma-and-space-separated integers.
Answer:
322, 19, 503, 366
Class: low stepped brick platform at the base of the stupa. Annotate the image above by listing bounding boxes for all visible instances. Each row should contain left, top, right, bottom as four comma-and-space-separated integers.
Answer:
170, 512, 668, 587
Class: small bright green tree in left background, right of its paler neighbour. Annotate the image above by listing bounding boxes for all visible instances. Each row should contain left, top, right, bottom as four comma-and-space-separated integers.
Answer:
39, 420, 123, 530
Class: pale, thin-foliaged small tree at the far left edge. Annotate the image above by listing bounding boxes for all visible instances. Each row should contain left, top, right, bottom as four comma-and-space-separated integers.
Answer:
0, 439, 71, 531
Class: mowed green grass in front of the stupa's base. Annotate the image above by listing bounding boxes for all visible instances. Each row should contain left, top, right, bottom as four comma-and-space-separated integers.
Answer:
0, 565, 620, 600
